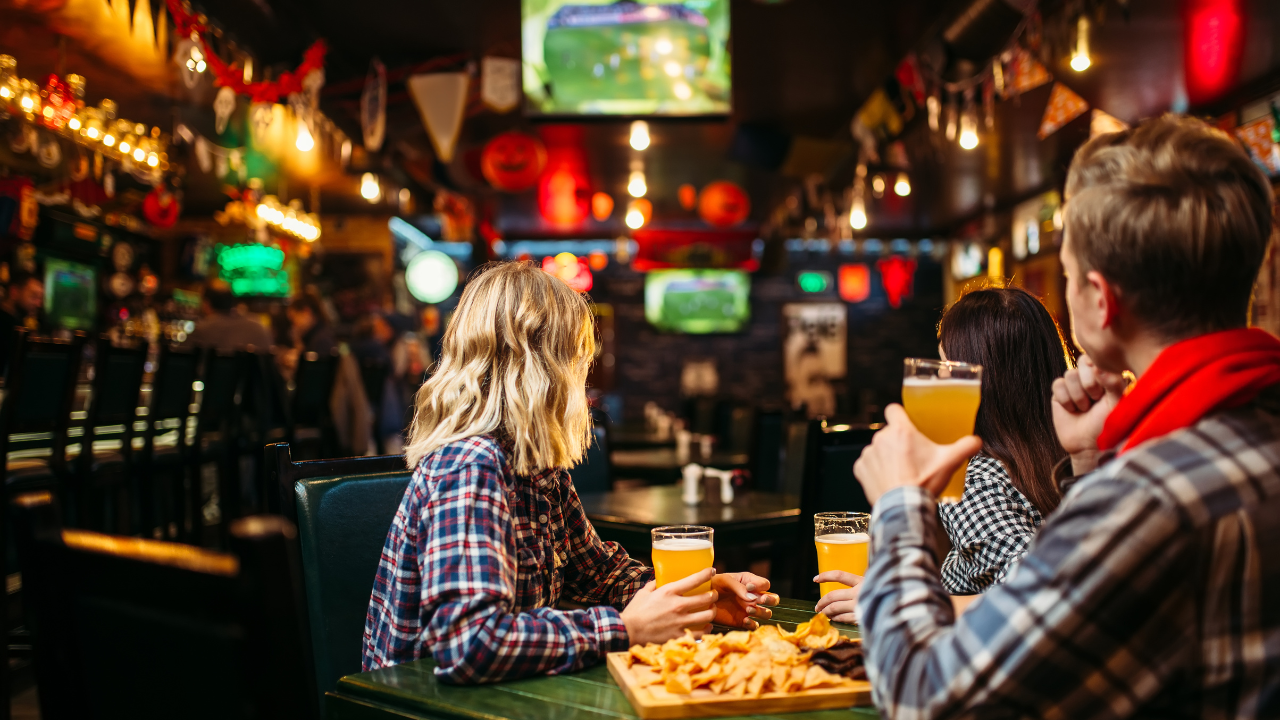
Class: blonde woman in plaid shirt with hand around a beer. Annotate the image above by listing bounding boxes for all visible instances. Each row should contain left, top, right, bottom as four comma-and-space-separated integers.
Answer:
364, 263, 777, 683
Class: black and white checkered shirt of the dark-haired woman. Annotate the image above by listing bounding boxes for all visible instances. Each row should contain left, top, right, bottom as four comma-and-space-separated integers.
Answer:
938, 455, 1044, 594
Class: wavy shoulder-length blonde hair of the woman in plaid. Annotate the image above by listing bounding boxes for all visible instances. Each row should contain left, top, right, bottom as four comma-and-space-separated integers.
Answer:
404, 263, 595, 475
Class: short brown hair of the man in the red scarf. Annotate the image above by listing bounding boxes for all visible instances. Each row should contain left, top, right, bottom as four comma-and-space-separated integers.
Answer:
1064, 115, 1274, 340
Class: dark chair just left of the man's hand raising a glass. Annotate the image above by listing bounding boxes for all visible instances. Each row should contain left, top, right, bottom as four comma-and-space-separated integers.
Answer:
788, 420, 879, 600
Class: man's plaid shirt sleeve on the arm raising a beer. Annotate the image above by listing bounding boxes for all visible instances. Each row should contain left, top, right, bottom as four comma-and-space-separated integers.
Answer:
859, 478, 1193, 719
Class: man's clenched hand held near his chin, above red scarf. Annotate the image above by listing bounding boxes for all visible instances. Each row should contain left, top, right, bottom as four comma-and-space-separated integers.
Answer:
1051, 355, 1129, 475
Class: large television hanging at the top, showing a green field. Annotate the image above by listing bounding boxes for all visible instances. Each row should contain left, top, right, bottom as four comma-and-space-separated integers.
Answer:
521, 0, 730, 115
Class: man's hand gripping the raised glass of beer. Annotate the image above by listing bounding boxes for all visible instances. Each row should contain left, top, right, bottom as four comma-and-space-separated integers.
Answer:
854, 405, 982, 505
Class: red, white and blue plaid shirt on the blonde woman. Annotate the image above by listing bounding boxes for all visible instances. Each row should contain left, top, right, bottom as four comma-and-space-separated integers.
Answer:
364, 436, 653, 683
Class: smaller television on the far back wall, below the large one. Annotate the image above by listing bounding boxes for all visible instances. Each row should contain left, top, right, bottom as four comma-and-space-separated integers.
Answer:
644, 270, 751, 334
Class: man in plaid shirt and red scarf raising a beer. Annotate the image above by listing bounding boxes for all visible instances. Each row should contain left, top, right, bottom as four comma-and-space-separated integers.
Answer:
854, 117, 1280, 720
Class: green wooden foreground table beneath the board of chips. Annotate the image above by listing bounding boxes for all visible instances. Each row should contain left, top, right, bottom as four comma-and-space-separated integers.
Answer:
325, 598, 878, 720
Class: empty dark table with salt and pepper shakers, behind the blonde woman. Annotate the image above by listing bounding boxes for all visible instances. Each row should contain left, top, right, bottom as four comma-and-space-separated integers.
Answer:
581, 486, 800, 557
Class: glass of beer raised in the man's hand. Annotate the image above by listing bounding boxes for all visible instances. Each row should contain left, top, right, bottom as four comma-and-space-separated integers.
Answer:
902, 357, 982, 502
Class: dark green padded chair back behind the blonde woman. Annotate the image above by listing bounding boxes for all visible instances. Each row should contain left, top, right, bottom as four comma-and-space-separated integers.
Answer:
266, 442, 412, 703
